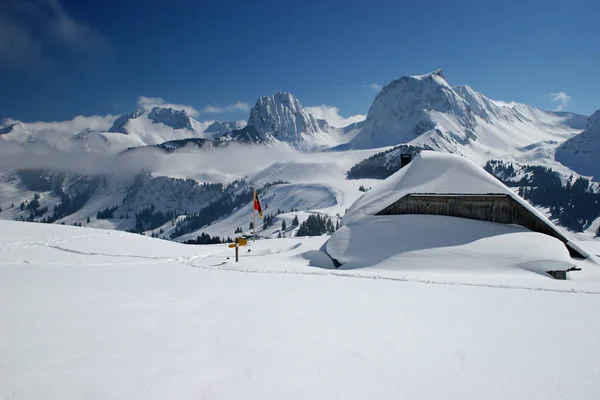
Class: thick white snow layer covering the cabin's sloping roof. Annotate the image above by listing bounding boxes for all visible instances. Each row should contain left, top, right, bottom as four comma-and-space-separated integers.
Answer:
343, 151, 584, 255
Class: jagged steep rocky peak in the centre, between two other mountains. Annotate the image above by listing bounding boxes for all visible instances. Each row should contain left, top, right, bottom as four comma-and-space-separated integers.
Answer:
248, 92, 321, 143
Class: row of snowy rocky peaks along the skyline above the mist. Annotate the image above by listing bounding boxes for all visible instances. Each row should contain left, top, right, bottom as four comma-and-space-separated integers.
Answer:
0, 70, 596, 164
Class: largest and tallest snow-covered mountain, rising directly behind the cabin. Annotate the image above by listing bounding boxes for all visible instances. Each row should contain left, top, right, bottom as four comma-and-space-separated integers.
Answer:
349, 70, 584, 162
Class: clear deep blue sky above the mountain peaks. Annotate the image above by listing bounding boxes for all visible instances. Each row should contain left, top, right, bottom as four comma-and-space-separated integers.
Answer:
0, 0, 600, 121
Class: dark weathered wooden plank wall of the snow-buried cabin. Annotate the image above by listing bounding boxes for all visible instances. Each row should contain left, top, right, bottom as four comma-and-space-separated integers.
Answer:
377, 193, 585, 258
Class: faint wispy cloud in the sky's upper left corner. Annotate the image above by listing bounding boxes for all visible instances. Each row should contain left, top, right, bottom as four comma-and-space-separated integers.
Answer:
0, 0, 110, 68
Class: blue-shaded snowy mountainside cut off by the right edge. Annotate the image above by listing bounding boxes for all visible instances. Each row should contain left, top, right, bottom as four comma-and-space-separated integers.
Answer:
556, 110, 600, 180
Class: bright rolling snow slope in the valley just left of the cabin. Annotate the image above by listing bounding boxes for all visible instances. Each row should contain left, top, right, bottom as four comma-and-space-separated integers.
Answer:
169, 148, 379, 240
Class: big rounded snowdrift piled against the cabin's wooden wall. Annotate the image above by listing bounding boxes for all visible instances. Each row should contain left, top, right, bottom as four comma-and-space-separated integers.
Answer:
325, 215, 575, 277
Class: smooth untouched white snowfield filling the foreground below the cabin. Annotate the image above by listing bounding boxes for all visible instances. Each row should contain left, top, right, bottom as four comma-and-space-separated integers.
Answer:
0, 221, 600, 400
